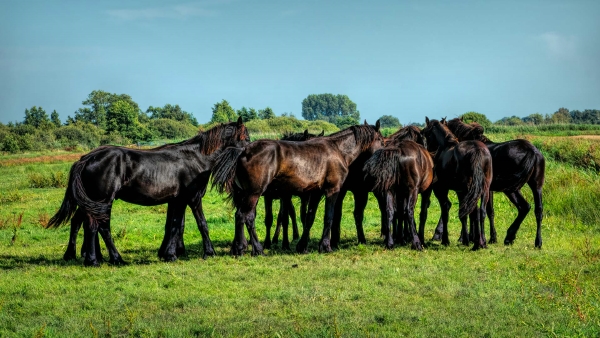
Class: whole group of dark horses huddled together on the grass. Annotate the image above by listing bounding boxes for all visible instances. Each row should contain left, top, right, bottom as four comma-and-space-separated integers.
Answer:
48, 118, 545, 266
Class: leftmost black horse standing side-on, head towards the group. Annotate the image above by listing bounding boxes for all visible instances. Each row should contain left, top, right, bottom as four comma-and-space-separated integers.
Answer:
48, 118, 250, 266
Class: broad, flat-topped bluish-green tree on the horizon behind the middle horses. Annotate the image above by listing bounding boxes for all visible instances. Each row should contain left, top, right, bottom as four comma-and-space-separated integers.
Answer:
302, 94, 360, 127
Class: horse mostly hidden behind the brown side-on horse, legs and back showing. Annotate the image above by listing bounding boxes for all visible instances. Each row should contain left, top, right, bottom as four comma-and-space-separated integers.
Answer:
263, 129, 325, 250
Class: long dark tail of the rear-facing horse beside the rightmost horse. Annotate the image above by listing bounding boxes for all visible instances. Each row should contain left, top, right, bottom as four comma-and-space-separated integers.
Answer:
458, 147, 491, 217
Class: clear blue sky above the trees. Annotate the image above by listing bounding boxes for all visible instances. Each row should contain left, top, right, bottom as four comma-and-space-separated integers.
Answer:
0, 0, 600, 124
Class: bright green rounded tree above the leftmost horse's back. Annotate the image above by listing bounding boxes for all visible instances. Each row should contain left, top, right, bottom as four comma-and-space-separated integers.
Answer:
106, 101, 145, 142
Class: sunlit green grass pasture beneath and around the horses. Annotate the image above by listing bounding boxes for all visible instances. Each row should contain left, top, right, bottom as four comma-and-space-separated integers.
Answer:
0, 134, 600, 337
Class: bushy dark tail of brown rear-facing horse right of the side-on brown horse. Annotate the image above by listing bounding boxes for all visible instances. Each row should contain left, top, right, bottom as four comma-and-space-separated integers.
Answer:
363, 148, 402, 193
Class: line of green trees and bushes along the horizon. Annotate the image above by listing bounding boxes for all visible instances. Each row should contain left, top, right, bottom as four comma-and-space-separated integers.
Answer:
0, 90, 600, 153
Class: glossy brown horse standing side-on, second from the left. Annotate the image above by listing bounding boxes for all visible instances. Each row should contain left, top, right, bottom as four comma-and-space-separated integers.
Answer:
212, 121, 383, 256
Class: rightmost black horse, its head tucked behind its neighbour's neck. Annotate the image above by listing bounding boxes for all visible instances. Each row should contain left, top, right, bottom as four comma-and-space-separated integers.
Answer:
436, 118, 546, 248
